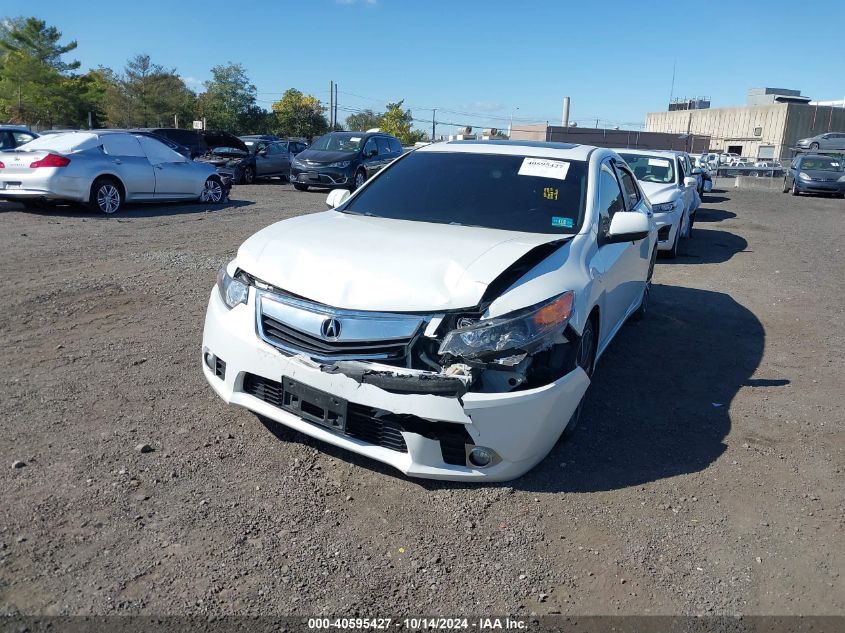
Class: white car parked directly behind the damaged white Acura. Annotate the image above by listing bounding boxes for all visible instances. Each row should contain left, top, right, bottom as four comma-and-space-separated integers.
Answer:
616, 149, 701, 257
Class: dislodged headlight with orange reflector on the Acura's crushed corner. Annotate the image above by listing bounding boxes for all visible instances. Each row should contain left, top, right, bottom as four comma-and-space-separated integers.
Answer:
438, 291, 575, 361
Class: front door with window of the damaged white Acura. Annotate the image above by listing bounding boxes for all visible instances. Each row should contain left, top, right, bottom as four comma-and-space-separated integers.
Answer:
596, 159, 647, 350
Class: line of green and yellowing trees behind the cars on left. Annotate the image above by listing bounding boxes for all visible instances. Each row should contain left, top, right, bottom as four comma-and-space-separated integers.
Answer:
0, 17, 425, 144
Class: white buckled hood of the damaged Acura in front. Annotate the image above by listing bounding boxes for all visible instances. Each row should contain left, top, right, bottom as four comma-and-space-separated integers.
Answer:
237, 211, 567, 312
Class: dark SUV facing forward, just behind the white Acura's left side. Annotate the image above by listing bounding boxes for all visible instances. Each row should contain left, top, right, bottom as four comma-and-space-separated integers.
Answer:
290, 132, 403, 191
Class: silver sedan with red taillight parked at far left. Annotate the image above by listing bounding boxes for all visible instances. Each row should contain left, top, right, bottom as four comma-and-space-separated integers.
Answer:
0, 130, 227, 214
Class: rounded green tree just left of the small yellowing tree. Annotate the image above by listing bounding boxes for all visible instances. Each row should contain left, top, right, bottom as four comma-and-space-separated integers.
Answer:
198, 62, 263, 134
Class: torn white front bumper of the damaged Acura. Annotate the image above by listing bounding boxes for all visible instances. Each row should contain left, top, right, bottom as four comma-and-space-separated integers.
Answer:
202, 289, 589, 481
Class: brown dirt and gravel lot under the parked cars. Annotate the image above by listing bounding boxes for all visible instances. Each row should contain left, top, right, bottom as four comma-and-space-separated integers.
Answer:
0, 183, 845, 616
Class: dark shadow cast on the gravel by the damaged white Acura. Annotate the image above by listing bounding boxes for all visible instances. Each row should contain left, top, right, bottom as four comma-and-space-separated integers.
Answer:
254, 285, 768, 492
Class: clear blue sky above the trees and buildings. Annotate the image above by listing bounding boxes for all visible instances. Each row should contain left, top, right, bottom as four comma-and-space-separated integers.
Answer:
0, 0, 845, 134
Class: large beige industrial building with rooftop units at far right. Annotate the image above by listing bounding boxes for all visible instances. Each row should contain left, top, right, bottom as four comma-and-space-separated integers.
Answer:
645, 88, 845, 160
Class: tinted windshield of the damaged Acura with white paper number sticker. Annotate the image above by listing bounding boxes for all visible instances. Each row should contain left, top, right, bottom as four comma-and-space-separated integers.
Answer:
342, 152, 588, 234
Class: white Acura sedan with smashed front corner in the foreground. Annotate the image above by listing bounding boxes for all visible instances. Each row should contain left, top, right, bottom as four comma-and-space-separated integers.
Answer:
202, 141, 656, 481
